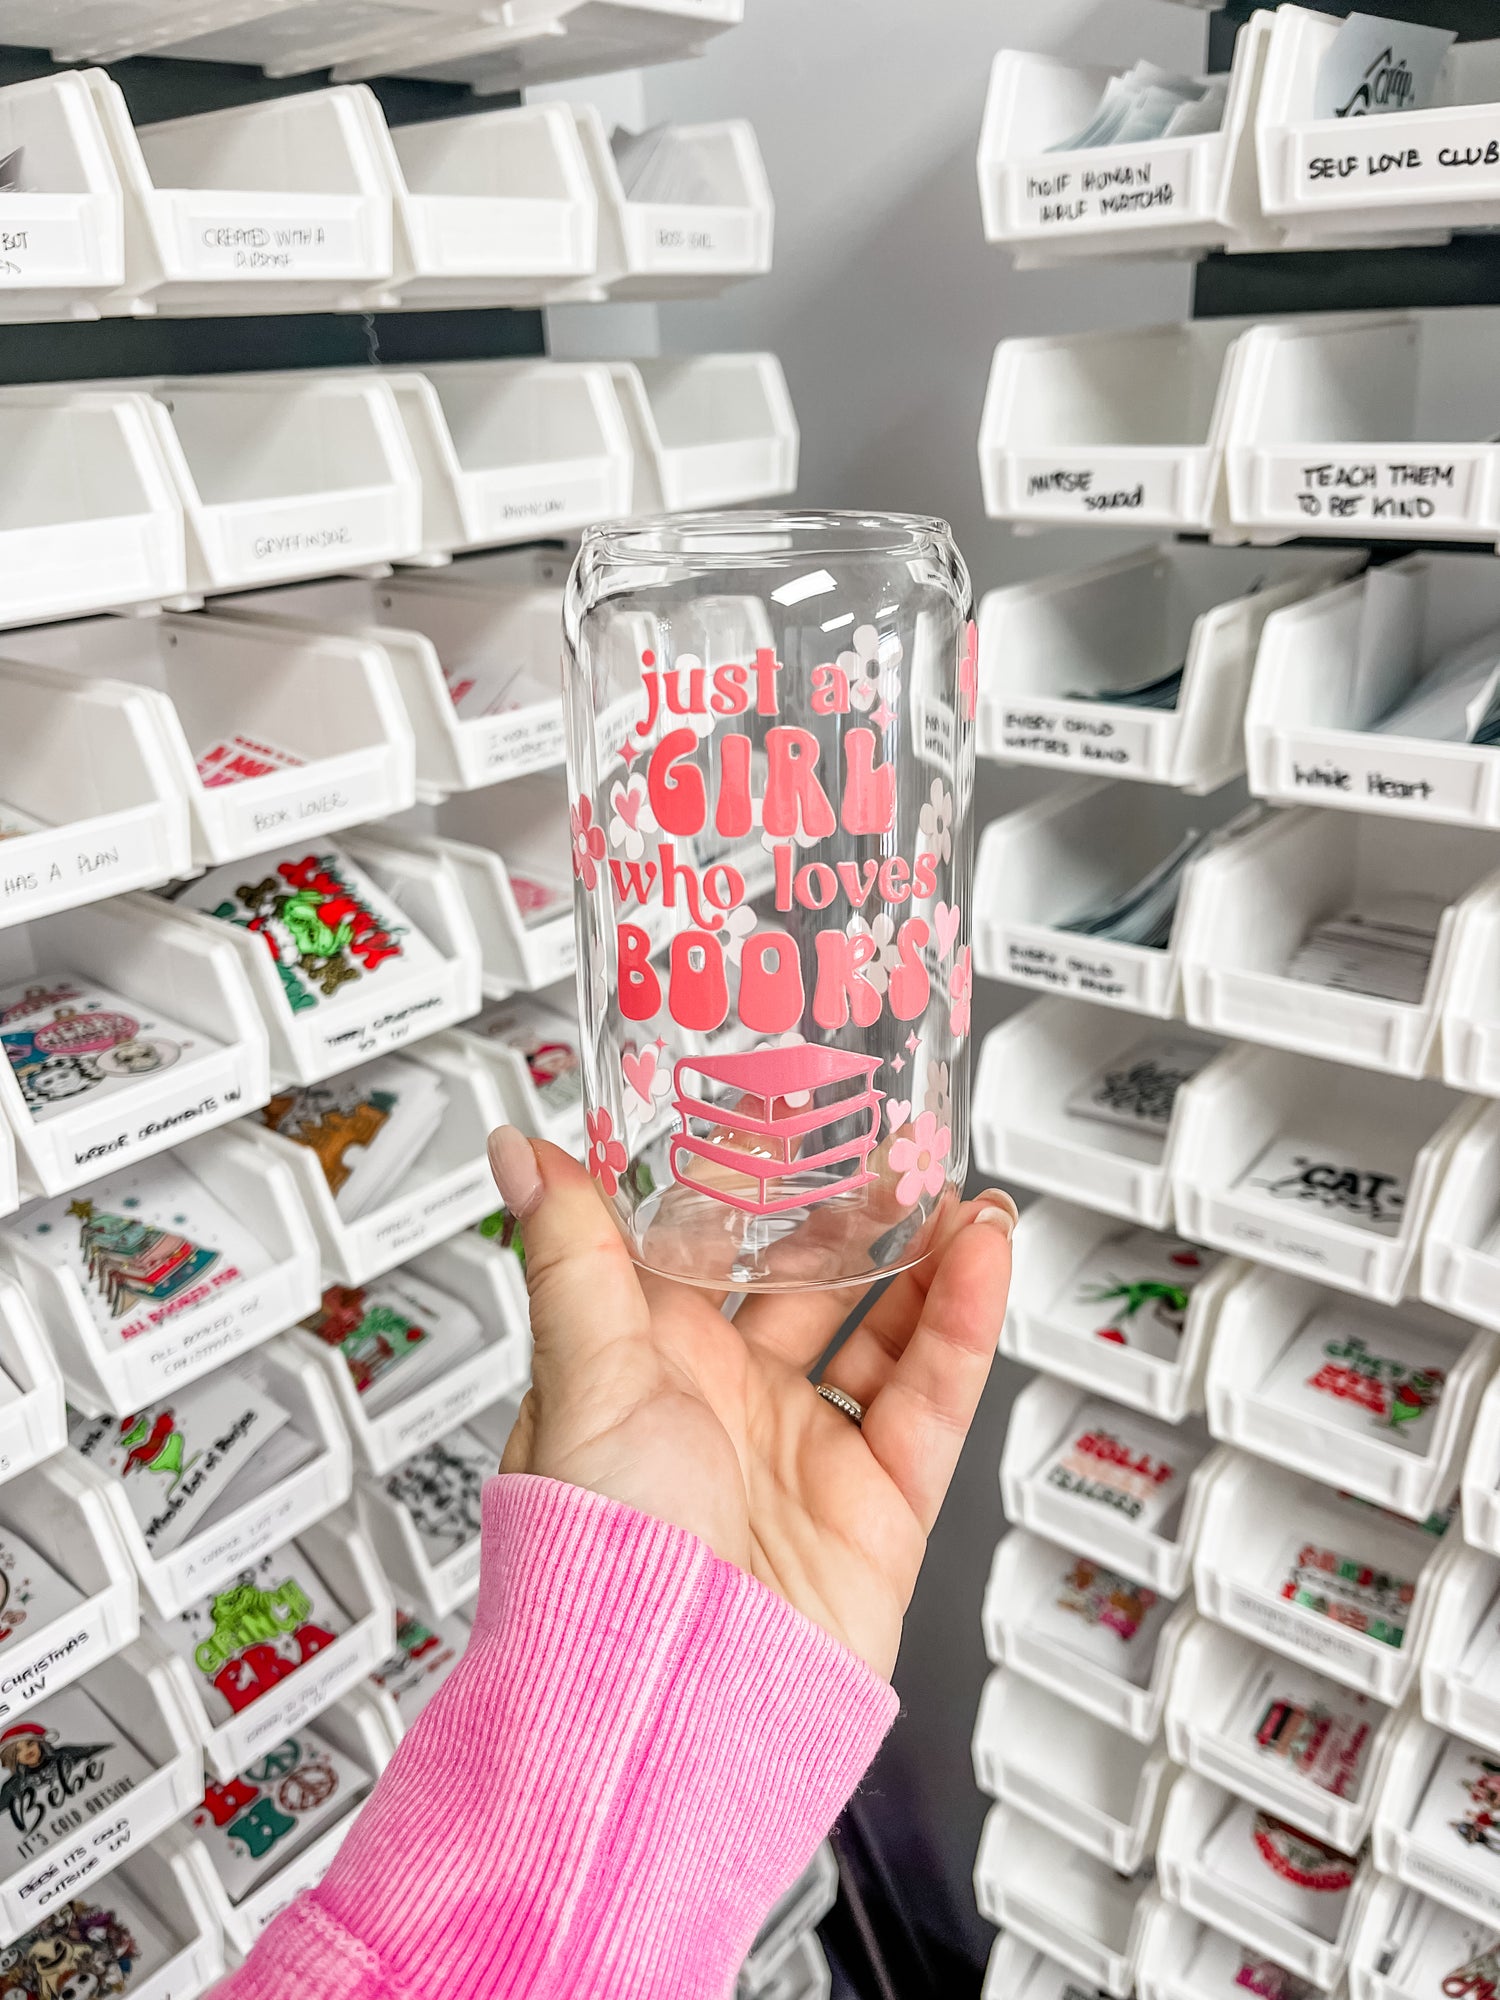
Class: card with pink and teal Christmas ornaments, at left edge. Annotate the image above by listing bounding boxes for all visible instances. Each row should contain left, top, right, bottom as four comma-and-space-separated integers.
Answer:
0, 974, 202, 1120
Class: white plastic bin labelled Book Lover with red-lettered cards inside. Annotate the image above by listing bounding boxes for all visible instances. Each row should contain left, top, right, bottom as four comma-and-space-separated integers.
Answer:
0, 604, 416, 866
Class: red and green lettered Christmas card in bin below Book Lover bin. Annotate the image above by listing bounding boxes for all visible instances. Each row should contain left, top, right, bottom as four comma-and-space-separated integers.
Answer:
194, 854, 406, 1014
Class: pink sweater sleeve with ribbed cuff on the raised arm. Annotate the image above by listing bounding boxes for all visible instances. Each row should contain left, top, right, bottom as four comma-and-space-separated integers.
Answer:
212, 1474, 896, 2000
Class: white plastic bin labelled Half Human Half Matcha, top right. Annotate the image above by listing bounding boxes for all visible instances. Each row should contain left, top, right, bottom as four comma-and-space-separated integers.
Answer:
980, 16, 1276, 270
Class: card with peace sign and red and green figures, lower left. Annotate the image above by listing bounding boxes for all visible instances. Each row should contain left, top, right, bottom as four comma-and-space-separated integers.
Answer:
192, 1726, 370, 1902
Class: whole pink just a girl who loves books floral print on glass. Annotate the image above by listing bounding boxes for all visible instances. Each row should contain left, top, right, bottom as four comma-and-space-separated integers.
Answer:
570, 624, 970, 1216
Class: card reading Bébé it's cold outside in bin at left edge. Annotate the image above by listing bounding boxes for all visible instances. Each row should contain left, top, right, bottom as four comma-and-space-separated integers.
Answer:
0, 1688, 152, 1862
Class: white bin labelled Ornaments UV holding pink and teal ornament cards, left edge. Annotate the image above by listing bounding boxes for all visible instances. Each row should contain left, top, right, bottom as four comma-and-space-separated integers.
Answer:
0, 896, 270, 1194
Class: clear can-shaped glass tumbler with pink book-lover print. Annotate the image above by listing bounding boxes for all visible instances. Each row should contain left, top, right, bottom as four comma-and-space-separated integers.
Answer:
564, 514, 978, 1292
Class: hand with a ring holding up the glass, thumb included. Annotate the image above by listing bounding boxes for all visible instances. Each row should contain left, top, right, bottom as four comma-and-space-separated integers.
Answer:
490, 1126, 1016, 1678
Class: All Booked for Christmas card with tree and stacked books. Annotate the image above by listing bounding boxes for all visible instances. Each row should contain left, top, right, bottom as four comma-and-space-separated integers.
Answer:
6, 1154, 270, 1344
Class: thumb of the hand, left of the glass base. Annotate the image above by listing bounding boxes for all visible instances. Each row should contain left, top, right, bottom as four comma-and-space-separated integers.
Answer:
490, 1126, 650, 1360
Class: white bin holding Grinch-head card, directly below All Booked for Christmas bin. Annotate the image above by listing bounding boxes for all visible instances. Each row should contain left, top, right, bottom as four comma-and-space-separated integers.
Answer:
72, 1340, 354, 1618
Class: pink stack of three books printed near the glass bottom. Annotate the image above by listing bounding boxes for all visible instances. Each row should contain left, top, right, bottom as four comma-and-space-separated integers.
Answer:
672, 1042, 884, 1216
